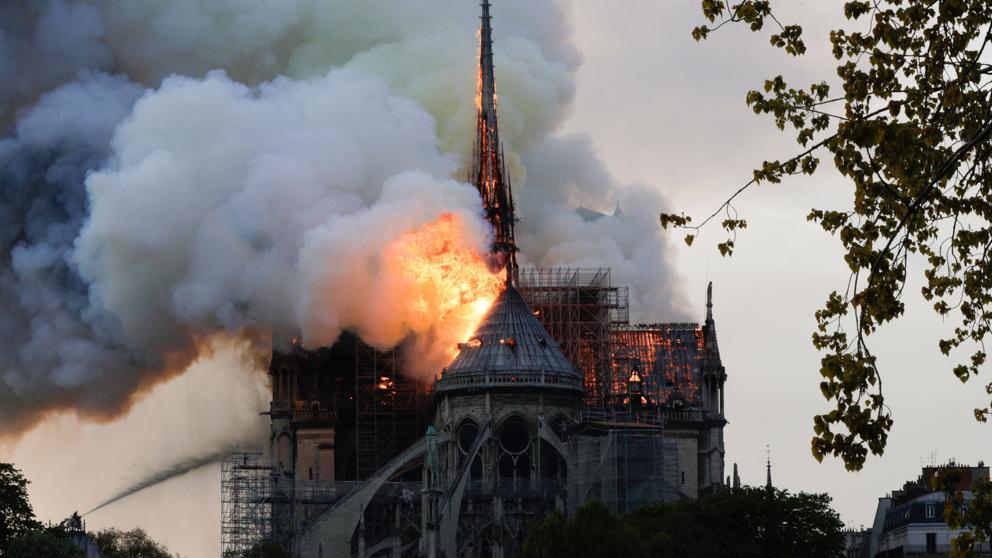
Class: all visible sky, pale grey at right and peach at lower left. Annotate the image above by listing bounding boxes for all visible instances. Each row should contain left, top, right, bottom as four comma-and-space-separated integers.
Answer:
0, 0, 992, 557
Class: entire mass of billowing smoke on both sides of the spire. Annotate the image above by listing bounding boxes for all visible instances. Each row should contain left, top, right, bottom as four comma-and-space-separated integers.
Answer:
0, 0, 683, 448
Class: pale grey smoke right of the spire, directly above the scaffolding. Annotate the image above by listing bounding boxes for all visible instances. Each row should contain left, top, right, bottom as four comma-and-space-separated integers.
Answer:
517, 136, 688, 322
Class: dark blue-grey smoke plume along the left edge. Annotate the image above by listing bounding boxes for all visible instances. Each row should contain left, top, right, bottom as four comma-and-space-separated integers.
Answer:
0, 74, 147, 432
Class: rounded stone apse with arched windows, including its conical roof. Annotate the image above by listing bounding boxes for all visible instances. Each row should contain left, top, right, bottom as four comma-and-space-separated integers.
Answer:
433, 284, 583, 557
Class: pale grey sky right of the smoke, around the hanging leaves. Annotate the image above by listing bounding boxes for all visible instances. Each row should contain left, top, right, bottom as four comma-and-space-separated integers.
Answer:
565, 0, 992, 536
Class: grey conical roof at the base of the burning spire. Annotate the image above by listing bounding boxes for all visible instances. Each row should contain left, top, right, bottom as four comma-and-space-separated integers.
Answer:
437, 285, 582, 391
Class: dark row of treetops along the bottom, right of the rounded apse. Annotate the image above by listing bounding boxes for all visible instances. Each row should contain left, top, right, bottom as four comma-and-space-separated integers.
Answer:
523, 487, 844, 558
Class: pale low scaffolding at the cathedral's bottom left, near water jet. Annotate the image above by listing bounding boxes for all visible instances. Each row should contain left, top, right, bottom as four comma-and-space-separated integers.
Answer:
220, 448, 273, 558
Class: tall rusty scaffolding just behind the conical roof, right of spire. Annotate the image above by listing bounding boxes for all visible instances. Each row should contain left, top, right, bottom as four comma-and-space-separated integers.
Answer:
519, 267, 630, 406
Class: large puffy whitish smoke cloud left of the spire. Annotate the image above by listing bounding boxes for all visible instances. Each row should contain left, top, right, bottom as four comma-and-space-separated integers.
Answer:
76, 70, 468, 351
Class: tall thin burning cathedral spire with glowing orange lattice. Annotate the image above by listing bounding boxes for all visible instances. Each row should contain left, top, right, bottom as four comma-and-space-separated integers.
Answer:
472, 0, 517, 284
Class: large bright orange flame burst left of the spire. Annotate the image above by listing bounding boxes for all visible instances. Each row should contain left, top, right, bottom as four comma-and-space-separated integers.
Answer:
386, 213, 506, 359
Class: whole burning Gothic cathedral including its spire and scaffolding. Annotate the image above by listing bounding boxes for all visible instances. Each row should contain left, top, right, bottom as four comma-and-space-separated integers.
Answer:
222, 0, 727, 558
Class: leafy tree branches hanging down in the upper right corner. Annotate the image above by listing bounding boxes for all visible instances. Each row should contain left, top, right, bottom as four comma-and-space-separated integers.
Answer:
661, 0, 992, 470
